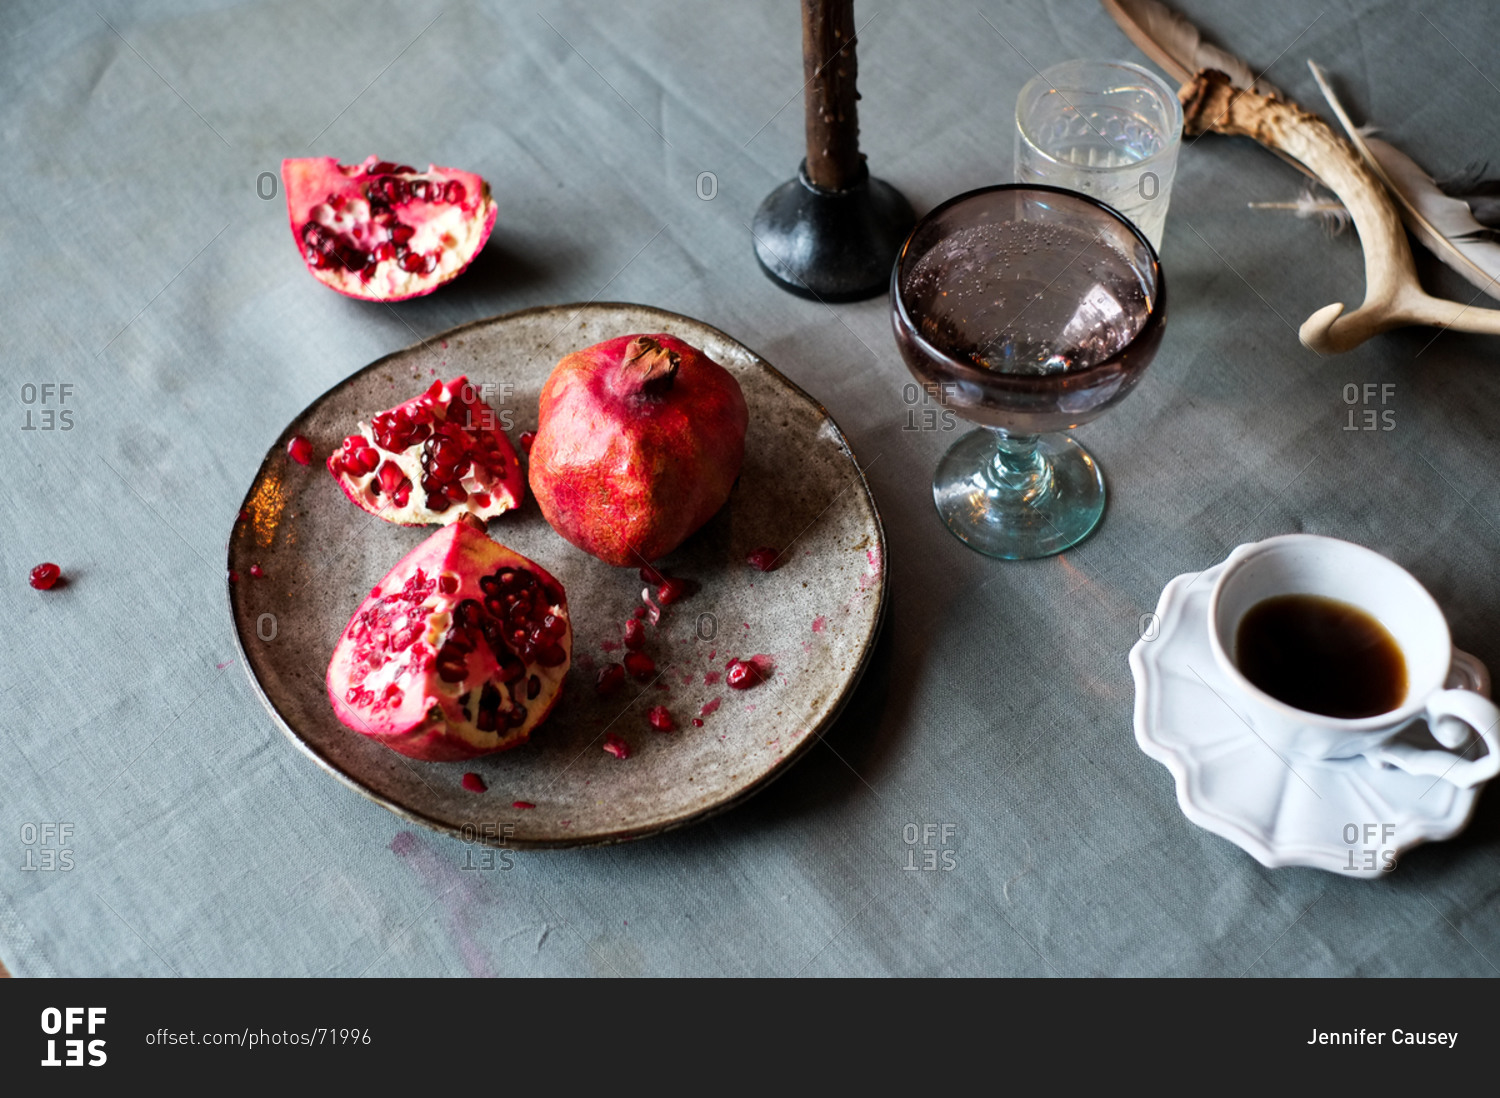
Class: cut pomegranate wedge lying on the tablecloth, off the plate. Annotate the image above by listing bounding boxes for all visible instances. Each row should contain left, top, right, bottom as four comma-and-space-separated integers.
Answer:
282, 156, 495, 302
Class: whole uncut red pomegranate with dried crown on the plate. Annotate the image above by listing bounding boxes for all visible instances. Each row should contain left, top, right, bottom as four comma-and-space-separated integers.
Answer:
530, 335, 749, 566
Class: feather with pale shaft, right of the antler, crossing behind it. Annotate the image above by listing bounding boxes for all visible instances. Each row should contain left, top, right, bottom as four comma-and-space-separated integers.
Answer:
1308, 60, 1500, 300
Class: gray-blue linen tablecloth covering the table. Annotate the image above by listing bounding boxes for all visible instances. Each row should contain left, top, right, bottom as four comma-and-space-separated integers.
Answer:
0, 0, 1500, 977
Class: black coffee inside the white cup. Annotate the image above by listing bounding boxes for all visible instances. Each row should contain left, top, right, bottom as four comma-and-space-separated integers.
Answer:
1235, 594, 1406, 719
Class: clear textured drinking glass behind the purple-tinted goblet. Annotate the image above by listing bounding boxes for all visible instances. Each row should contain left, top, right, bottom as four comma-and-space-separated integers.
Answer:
1016, 60, 1182, 249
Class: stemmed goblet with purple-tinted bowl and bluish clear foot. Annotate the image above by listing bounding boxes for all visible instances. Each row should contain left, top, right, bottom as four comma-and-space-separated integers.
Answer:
891, 183, 1167, 560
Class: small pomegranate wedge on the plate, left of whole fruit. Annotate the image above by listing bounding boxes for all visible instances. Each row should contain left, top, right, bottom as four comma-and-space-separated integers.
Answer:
329, 378, 527, 527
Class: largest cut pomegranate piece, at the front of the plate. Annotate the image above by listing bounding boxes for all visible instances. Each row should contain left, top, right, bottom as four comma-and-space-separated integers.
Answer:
327, 516, 573, 761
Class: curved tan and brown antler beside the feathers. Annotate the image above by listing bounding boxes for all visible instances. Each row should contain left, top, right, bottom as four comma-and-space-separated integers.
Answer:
1178, 69, 1500, 354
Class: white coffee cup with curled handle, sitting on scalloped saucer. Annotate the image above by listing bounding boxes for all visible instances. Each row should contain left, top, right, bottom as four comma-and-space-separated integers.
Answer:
1208, 534, 1500, 789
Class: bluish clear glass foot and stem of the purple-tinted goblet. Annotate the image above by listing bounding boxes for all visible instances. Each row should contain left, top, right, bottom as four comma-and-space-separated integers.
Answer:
933, 429, 1104, 561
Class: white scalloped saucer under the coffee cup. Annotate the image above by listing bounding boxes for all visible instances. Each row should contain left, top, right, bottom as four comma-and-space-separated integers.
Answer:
1130, 566, 1490, 878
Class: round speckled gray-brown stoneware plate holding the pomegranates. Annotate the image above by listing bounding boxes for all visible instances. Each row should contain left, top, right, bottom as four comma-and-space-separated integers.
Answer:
228, 305, 887, 848
